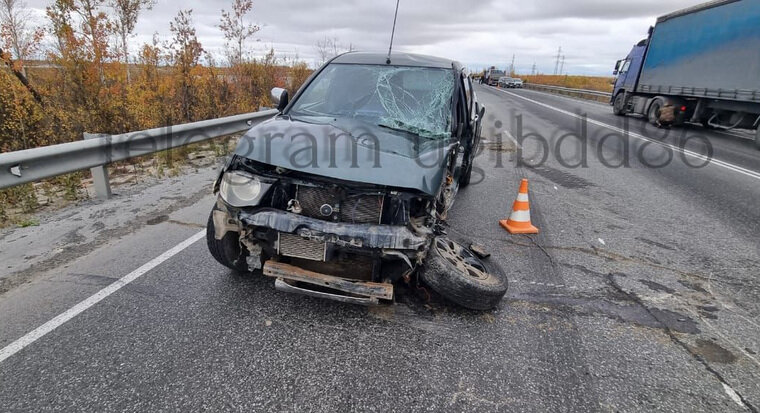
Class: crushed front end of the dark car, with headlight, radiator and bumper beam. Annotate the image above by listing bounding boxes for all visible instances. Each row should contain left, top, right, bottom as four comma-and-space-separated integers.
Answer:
212, 156, 436, 304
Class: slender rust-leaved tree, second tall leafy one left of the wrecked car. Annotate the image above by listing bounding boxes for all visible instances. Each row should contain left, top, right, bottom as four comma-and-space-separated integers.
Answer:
169, 9, 203, 122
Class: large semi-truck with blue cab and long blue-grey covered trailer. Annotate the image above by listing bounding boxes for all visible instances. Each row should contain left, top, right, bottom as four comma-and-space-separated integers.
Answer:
610, 0, 760, 149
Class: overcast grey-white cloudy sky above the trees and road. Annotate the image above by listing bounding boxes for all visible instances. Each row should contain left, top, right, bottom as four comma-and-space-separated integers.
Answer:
27, 0, 701, 75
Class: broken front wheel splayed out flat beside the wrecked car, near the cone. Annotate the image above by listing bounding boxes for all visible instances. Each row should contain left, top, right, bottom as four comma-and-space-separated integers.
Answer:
420, 237, 509, 310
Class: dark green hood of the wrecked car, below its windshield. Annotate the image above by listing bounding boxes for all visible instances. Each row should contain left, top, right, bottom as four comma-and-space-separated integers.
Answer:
235, 116, 456, 195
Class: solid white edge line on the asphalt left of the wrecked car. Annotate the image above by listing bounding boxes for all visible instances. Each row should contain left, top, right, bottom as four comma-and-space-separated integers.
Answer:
0, 230, 206, 363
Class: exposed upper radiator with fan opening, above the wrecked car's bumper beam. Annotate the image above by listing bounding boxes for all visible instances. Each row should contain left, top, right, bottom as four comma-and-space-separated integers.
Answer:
296, 185, 383, 224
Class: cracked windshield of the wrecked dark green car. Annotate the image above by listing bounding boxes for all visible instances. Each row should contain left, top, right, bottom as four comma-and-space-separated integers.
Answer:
289, 64, 454, 139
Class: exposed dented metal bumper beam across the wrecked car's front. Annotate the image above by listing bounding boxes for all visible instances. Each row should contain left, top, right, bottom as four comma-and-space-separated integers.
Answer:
238, 208, 428, 251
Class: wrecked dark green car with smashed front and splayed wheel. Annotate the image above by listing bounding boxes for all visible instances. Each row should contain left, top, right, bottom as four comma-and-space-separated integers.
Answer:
207, 53, 507, 309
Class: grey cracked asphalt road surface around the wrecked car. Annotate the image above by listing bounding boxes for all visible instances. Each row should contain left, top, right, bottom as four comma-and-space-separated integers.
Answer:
0, 87, 760, 412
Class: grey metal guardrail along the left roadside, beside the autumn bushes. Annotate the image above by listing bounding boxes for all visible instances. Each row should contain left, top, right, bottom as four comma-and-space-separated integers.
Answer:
0, 109, 277, 198
